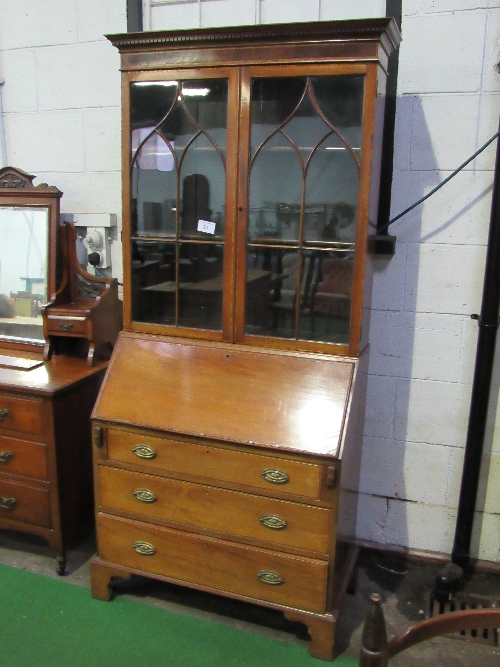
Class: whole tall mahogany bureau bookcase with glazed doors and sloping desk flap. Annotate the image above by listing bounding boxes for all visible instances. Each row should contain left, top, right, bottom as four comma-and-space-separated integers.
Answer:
91, 19, 399, 659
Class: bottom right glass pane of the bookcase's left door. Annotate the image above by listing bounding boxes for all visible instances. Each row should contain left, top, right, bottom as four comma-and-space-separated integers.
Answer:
179, 243, 224, 330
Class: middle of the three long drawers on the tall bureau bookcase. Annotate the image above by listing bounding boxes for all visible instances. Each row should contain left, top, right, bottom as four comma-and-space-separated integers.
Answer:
99, 466, 331, 555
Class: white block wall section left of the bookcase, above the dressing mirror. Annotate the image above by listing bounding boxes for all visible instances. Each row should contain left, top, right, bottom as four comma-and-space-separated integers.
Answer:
0, 0, 127, 280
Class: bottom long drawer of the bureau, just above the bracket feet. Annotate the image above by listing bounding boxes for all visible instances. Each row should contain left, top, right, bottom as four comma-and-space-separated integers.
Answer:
98, 514, 328, 613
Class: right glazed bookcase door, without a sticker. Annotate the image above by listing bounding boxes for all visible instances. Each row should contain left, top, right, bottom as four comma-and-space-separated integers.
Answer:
236, 65, 371, 353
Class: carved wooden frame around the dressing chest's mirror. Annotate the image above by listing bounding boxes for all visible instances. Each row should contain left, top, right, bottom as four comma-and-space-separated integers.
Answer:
0, 167, 63, 352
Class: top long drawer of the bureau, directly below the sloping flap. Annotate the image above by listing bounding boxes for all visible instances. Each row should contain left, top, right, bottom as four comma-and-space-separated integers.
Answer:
108, 429, 322, 498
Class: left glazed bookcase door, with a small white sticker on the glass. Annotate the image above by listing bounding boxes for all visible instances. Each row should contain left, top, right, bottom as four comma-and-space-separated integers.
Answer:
126, 70, 240, 338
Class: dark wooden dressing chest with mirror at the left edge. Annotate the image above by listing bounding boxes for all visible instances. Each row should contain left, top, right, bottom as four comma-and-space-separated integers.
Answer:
0, 167, 121, 574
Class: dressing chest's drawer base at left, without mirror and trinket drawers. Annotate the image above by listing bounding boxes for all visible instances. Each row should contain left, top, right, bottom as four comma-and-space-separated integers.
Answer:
0, 353, 105, 574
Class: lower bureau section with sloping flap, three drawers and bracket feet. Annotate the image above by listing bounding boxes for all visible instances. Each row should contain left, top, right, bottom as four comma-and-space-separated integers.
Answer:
91, 333, 355, 659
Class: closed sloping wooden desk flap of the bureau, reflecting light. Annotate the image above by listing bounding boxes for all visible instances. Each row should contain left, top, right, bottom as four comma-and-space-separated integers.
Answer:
92, 332, 356, 457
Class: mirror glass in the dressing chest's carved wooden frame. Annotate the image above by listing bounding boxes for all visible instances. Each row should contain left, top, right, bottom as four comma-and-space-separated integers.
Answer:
0, 206, 49, 341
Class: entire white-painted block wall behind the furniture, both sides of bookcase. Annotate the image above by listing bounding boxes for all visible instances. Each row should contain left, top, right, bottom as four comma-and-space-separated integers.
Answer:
0, 0, 500, 562
